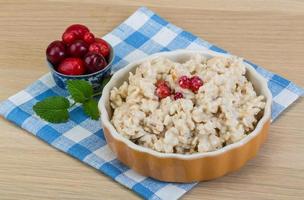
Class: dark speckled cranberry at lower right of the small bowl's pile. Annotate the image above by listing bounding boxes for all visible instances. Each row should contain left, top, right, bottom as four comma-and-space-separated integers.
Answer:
84, 52, 107, 73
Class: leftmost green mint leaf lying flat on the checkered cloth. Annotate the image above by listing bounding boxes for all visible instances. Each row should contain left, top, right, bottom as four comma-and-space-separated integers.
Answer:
33, 96, 70, 123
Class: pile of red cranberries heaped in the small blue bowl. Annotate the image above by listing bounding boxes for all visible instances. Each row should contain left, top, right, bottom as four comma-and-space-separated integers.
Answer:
46, 24, 110, 75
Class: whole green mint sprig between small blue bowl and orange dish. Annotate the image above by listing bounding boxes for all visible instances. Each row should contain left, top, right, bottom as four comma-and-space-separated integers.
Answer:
33, 77, 111, 123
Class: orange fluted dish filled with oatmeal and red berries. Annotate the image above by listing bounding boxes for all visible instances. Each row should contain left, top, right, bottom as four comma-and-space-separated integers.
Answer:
99, 50, 272, 182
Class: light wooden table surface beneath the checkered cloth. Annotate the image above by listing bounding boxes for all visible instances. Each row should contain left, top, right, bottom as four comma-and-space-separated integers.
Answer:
0, 0, 304, 200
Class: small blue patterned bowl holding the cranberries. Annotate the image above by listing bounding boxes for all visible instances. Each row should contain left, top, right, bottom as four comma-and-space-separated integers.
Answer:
47, 43, 115, 90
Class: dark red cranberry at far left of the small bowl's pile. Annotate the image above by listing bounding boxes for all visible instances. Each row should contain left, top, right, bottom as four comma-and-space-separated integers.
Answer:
46, 40, 66, 65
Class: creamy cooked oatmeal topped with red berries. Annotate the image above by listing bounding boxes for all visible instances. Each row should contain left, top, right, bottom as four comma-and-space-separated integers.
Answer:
110, 54, 265, 154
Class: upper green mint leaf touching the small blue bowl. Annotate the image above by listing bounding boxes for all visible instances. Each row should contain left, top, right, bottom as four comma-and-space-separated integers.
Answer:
67, 80, 93, 103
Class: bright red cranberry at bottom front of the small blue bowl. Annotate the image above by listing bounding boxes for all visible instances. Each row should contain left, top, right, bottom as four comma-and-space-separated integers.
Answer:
57, 58, 85, 75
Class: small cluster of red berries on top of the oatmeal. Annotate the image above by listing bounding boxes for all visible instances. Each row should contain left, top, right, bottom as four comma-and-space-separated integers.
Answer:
155, 76, 204, 100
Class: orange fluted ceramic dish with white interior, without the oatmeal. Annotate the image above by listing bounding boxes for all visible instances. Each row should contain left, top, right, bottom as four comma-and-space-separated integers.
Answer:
98, 50, 272, 182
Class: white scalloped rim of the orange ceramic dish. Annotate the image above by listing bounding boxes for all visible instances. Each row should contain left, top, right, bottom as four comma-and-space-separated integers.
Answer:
98, 49, 272, 160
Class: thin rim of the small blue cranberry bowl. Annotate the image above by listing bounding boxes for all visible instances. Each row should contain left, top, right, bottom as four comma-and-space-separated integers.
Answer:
46, 40, 115, 78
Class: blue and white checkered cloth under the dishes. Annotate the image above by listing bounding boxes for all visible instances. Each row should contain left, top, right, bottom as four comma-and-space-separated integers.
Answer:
0, 7, 304, 199
